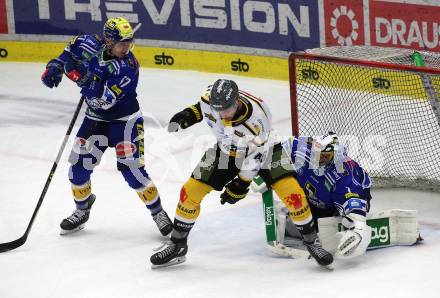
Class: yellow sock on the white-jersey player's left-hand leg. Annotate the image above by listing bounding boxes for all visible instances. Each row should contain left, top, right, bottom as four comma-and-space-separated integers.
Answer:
176, 178, 213, 223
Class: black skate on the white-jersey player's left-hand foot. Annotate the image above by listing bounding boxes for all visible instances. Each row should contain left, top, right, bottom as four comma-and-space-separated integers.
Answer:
150, 240, 188, 269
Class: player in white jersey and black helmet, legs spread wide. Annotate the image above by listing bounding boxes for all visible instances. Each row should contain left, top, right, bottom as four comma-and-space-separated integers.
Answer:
150, 79, 333, 268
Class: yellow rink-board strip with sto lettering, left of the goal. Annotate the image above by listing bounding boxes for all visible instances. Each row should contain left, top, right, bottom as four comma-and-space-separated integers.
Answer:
0, 41, 288, 80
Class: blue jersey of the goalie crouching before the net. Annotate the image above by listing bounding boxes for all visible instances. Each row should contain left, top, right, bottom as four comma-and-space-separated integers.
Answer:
283, 137, 371, 216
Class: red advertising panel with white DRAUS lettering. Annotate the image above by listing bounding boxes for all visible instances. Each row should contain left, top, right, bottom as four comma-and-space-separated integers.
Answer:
370, 0, 440, 52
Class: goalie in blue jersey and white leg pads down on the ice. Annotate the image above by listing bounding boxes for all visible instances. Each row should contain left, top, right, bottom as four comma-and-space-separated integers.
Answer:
252, 132, 422, 259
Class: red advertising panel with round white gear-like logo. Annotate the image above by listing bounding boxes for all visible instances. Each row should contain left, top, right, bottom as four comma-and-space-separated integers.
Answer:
324, 0, 365, 46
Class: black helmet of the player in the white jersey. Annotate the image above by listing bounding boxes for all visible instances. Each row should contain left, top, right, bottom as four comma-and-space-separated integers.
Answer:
209, 79, 238, 112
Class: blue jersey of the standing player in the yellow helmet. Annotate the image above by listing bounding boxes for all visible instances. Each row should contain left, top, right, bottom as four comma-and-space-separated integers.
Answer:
59, 35, 139, 121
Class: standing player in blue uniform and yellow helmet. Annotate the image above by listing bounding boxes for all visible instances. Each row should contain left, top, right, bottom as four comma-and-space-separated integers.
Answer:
41, 17, 172, 235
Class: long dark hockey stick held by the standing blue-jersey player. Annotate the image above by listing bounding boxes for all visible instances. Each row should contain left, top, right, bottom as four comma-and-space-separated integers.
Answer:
0, 96, 84, 253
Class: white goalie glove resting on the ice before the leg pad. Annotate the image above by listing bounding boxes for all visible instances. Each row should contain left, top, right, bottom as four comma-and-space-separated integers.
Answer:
335, 213, 371, 259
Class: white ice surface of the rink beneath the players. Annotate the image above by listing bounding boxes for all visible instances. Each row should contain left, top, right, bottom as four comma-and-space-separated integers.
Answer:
0, 63, 440, 298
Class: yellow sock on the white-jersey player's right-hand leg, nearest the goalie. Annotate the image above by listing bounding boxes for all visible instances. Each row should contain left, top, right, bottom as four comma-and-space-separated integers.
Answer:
272, 177, 313, 226
